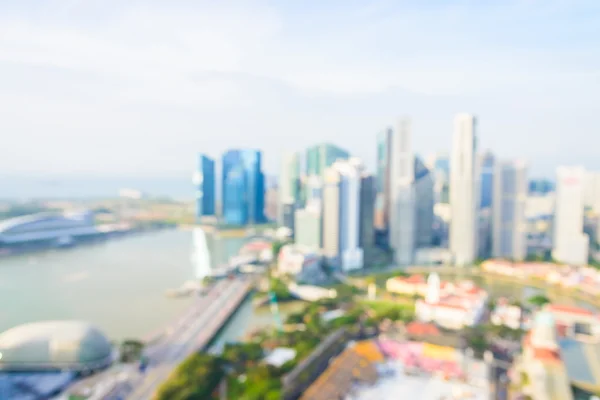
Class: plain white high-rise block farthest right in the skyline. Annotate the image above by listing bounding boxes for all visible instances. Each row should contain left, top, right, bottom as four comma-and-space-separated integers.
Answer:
552, 167, 589, 265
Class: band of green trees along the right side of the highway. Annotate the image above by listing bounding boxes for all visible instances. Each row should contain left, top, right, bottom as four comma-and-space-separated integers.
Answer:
156, 292, 414, 400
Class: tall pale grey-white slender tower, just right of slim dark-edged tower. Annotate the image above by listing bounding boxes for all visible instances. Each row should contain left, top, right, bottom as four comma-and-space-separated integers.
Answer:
390, 118, 416, 265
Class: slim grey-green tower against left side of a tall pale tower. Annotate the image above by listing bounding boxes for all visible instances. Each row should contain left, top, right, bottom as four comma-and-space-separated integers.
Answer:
374, 128, 393, 231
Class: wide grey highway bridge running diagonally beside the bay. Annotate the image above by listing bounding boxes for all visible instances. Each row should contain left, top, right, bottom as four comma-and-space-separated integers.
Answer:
94, 278, 252, 400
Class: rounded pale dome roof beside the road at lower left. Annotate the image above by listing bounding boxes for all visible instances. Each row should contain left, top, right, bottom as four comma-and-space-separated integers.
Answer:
0, 321, 113, 371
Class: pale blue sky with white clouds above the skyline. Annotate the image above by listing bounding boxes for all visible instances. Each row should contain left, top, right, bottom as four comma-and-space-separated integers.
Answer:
0, 0, 600, 184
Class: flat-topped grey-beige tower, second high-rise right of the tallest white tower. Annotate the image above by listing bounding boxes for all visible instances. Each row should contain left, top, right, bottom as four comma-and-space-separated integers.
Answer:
492, 161, 528, 261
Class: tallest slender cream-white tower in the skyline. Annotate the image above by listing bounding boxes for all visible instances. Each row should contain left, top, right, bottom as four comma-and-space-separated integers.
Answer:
450, 114, 480, 266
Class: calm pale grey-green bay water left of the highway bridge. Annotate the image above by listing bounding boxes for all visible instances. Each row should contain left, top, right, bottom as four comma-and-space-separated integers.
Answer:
0, 230, 244, 339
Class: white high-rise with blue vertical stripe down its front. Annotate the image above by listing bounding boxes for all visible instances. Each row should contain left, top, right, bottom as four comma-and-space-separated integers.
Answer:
323, 158, 363, 271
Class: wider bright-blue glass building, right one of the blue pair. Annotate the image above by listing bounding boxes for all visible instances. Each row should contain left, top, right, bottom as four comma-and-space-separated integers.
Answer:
222, 150, 266, 225
